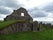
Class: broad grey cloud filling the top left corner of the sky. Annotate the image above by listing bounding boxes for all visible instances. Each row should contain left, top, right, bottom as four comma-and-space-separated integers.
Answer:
0, 0, 21, 9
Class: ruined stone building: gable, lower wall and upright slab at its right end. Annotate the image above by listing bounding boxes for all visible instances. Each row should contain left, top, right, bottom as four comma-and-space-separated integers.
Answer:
0, 7, 39, 34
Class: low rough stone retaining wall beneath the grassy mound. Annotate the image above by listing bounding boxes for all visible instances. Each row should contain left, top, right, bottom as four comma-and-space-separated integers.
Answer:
0, 22, 32, 34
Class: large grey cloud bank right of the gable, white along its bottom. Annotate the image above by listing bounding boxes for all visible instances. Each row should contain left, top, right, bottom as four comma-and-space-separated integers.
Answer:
29, 6, 53, 22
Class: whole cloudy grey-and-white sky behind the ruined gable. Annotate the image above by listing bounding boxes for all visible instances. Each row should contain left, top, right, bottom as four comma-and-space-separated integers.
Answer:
0, 0, 53, 22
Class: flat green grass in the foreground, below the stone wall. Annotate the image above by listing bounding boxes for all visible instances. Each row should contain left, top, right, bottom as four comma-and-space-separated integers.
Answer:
0, 29, 53, 40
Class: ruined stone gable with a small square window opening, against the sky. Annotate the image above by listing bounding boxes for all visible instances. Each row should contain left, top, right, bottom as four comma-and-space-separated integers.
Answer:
4, 7, 33, 22
